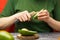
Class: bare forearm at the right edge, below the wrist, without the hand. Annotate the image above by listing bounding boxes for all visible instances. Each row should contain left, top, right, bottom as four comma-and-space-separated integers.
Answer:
46, 17, 60, 31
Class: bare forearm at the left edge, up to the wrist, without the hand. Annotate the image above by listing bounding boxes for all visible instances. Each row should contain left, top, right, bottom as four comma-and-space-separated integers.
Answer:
0, 16, 17, 29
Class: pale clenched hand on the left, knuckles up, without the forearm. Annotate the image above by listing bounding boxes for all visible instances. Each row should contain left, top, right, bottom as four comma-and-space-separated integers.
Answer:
15, 11, 31, 22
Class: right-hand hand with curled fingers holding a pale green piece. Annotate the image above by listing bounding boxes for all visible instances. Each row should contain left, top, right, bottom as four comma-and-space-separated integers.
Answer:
38, 9, 50, 22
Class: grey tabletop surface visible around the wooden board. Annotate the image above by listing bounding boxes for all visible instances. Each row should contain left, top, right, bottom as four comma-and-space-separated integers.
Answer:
11, 32, 60, 40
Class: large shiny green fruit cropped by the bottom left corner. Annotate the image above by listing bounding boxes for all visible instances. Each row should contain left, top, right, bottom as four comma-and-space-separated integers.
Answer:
0, 31, 14, 40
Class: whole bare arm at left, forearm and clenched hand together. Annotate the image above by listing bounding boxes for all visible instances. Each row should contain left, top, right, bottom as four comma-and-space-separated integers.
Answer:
0, 11, 31, 28
